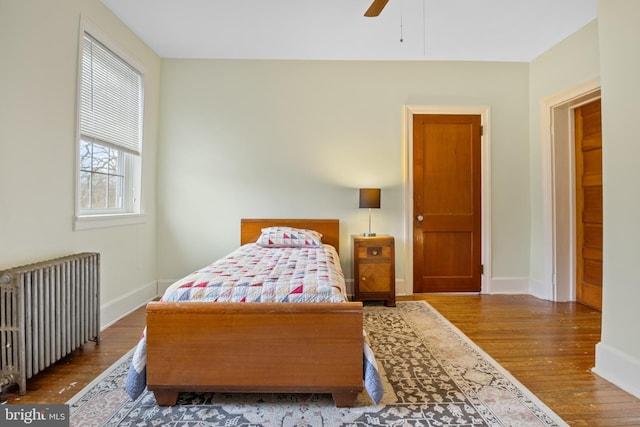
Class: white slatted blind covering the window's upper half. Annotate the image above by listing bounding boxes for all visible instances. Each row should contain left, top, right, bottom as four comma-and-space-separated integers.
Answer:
80, 33, 142, 154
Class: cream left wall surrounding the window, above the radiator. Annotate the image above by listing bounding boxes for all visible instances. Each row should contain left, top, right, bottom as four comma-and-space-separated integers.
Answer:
0, 0, 160, 325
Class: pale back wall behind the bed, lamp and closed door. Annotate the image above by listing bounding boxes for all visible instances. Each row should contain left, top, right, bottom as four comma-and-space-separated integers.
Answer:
158, 59, 530, 291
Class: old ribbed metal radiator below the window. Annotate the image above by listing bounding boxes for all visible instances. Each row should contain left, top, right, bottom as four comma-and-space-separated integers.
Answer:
0, 252, 100, 395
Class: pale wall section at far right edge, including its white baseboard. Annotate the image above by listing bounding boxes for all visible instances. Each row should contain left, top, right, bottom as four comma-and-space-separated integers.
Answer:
596, 0, 640, 397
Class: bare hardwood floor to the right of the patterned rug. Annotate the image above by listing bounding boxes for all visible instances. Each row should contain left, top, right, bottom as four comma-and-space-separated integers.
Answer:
408, 294, 640, 426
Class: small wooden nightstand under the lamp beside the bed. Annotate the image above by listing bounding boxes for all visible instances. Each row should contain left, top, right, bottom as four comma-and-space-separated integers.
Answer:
351, 235, 396, 307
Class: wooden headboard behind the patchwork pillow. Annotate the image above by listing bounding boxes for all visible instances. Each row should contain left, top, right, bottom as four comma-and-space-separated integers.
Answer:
240, 218, 340, 252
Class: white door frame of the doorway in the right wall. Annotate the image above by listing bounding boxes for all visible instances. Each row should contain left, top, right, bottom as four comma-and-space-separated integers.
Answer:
539, 79, 601, 301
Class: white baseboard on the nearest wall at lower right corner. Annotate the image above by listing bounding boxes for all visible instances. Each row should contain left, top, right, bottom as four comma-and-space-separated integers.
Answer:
592, 342, 640, 399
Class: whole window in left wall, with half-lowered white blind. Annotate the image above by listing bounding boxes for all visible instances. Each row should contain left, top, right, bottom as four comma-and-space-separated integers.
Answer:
77, 33, 143, 221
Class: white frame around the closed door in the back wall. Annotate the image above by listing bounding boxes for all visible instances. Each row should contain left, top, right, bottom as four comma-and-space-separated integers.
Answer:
398, 105, 491, 295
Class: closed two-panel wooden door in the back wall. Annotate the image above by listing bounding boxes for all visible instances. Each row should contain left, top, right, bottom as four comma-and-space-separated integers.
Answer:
413, 114, 482, 293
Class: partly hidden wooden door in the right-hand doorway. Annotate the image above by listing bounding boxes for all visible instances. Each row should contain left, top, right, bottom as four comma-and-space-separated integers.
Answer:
574, 99, 602, 310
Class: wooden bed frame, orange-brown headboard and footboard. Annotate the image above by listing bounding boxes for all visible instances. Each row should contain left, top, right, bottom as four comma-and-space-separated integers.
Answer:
146, 219, 363, 407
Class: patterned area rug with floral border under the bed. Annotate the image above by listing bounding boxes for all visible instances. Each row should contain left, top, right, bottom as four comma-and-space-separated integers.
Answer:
68, 301, 567, 427
